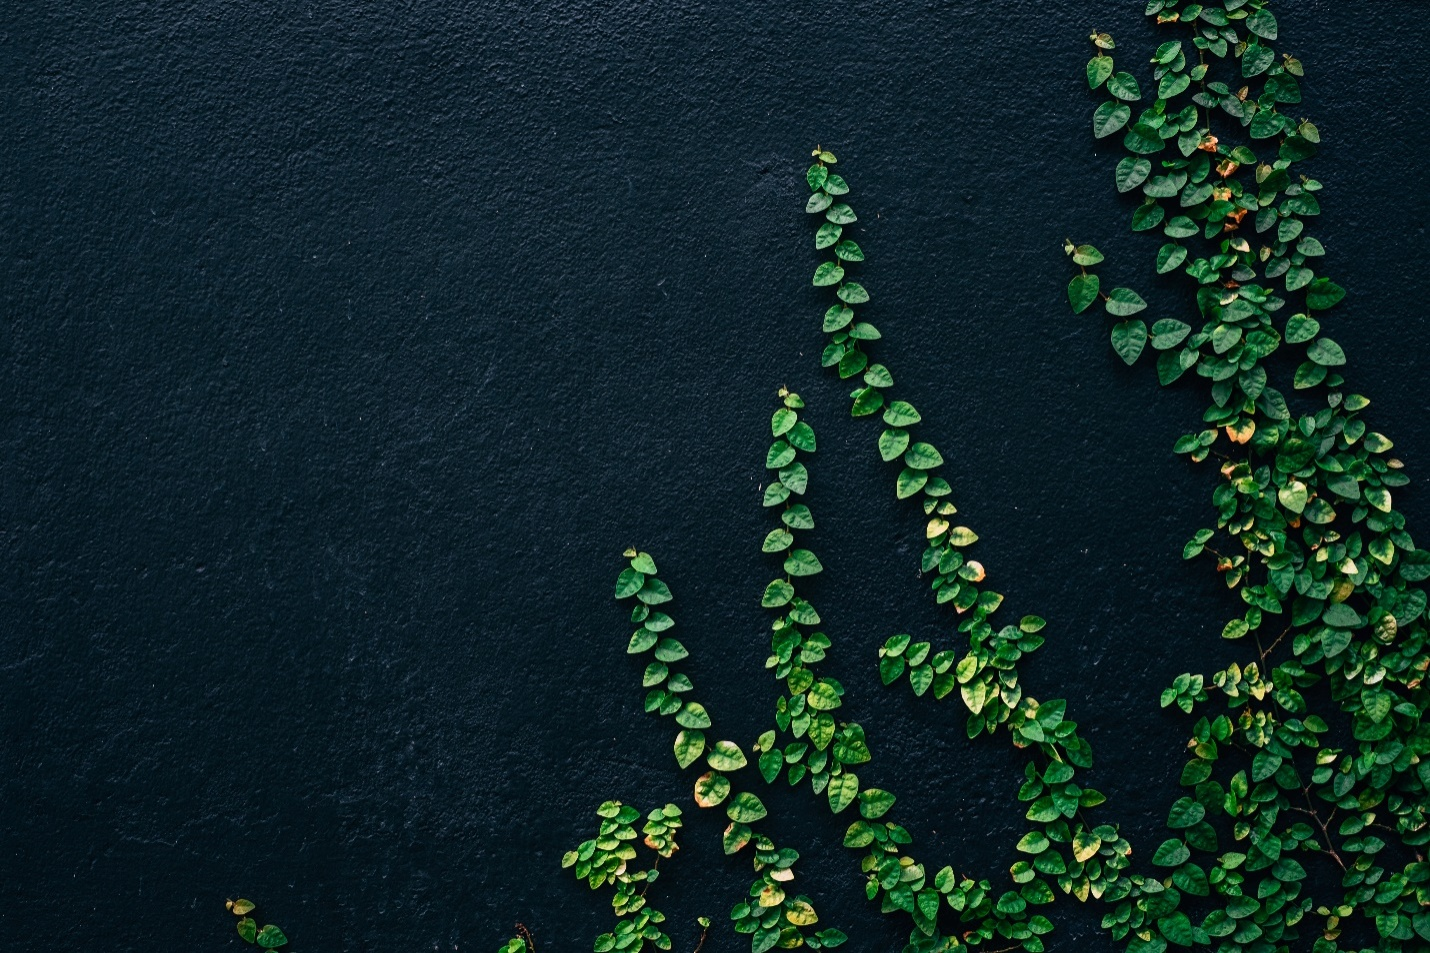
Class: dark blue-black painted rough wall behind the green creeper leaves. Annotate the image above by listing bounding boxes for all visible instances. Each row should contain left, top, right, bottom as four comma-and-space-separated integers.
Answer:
0, 0, 1430, 953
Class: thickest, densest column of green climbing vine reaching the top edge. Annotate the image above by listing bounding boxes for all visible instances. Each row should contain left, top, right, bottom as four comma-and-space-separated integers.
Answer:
1065, 0, 1430, 953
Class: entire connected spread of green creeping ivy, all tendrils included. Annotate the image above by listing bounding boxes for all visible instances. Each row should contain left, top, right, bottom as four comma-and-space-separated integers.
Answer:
486, 0, 1430, 953
